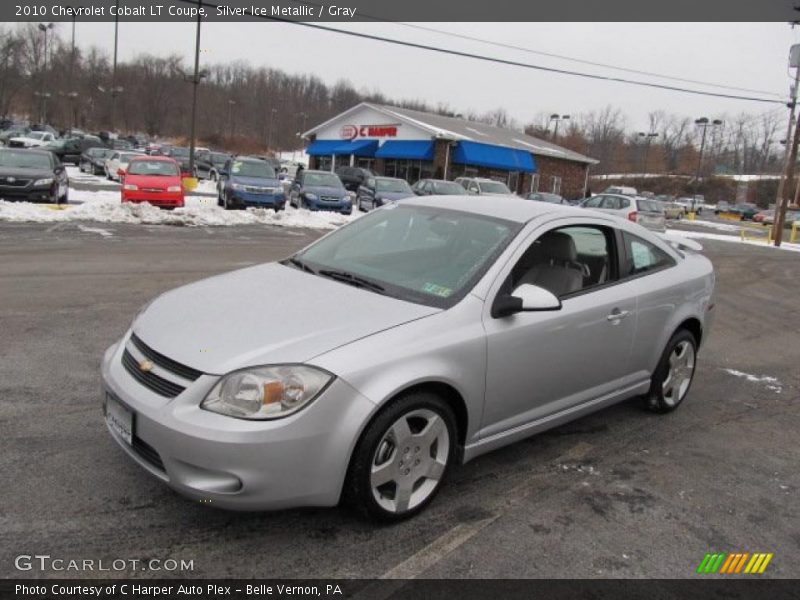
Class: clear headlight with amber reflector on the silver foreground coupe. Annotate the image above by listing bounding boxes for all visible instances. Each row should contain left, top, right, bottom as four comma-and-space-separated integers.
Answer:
205, 365, 333, 420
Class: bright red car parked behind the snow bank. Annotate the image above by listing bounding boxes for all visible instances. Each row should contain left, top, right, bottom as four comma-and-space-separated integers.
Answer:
122, 156, 184, 208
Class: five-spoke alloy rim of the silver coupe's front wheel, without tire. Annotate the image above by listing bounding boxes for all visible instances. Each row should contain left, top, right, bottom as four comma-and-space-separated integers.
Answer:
370, 408, 450, 514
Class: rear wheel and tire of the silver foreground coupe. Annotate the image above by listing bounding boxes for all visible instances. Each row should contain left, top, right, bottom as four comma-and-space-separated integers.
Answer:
646, 329, 697, 413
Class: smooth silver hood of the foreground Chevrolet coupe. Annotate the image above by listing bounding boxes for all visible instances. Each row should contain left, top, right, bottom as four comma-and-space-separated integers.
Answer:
133, 263, 441, 375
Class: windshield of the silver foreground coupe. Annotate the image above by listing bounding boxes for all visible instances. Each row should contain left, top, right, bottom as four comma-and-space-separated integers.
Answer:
295, 205, 521, 308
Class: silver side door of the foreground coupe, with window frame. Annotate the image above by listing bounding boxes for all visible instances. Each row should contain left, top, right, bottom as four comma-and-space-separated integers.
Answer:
481, 218, 637, 436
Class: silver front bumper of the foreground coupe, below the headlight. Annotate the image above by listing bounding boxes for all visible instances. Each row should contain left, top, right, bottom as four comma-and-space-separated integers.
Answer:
102, 335, 375, 510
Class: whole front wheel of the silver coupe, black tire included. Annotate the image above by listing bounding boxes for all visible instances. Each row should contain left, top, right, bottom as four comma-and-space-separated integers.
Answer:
344, 392, 457, 522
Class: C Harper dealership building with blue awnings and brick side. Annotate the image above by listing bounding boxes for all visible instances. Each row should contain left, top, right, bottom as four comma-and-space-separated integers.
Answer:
303, 102, 598, 198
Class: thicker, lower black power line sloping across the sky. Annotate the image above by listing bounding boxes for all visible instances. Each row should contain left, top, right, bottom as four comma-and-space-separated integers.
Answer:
181, 0, 784, 104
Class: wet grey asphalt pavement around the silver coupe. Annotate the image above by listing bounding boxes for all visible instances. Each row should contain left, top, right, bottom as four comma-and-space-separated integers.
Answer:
0, 223, 800, 578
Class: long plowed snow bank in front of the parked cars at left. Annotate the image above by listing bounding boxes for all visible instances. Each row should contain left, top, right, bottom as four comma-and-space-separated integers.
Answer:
0, 192, 358, 229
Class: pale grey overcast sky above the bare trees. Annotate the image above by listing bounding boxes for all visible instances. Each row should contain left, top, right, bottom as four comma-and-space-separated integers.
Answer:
25, 22, 800, 129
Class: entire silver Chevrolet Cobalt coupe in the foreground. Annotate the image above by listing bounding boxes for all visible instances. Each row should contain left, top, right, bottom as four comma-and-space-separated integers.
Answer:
102, 196, 714, 520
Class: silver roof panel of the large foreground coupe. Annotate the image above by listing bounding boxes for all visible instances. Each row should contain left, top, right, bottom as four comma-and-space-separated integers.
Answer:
401, 195, 594, 223
